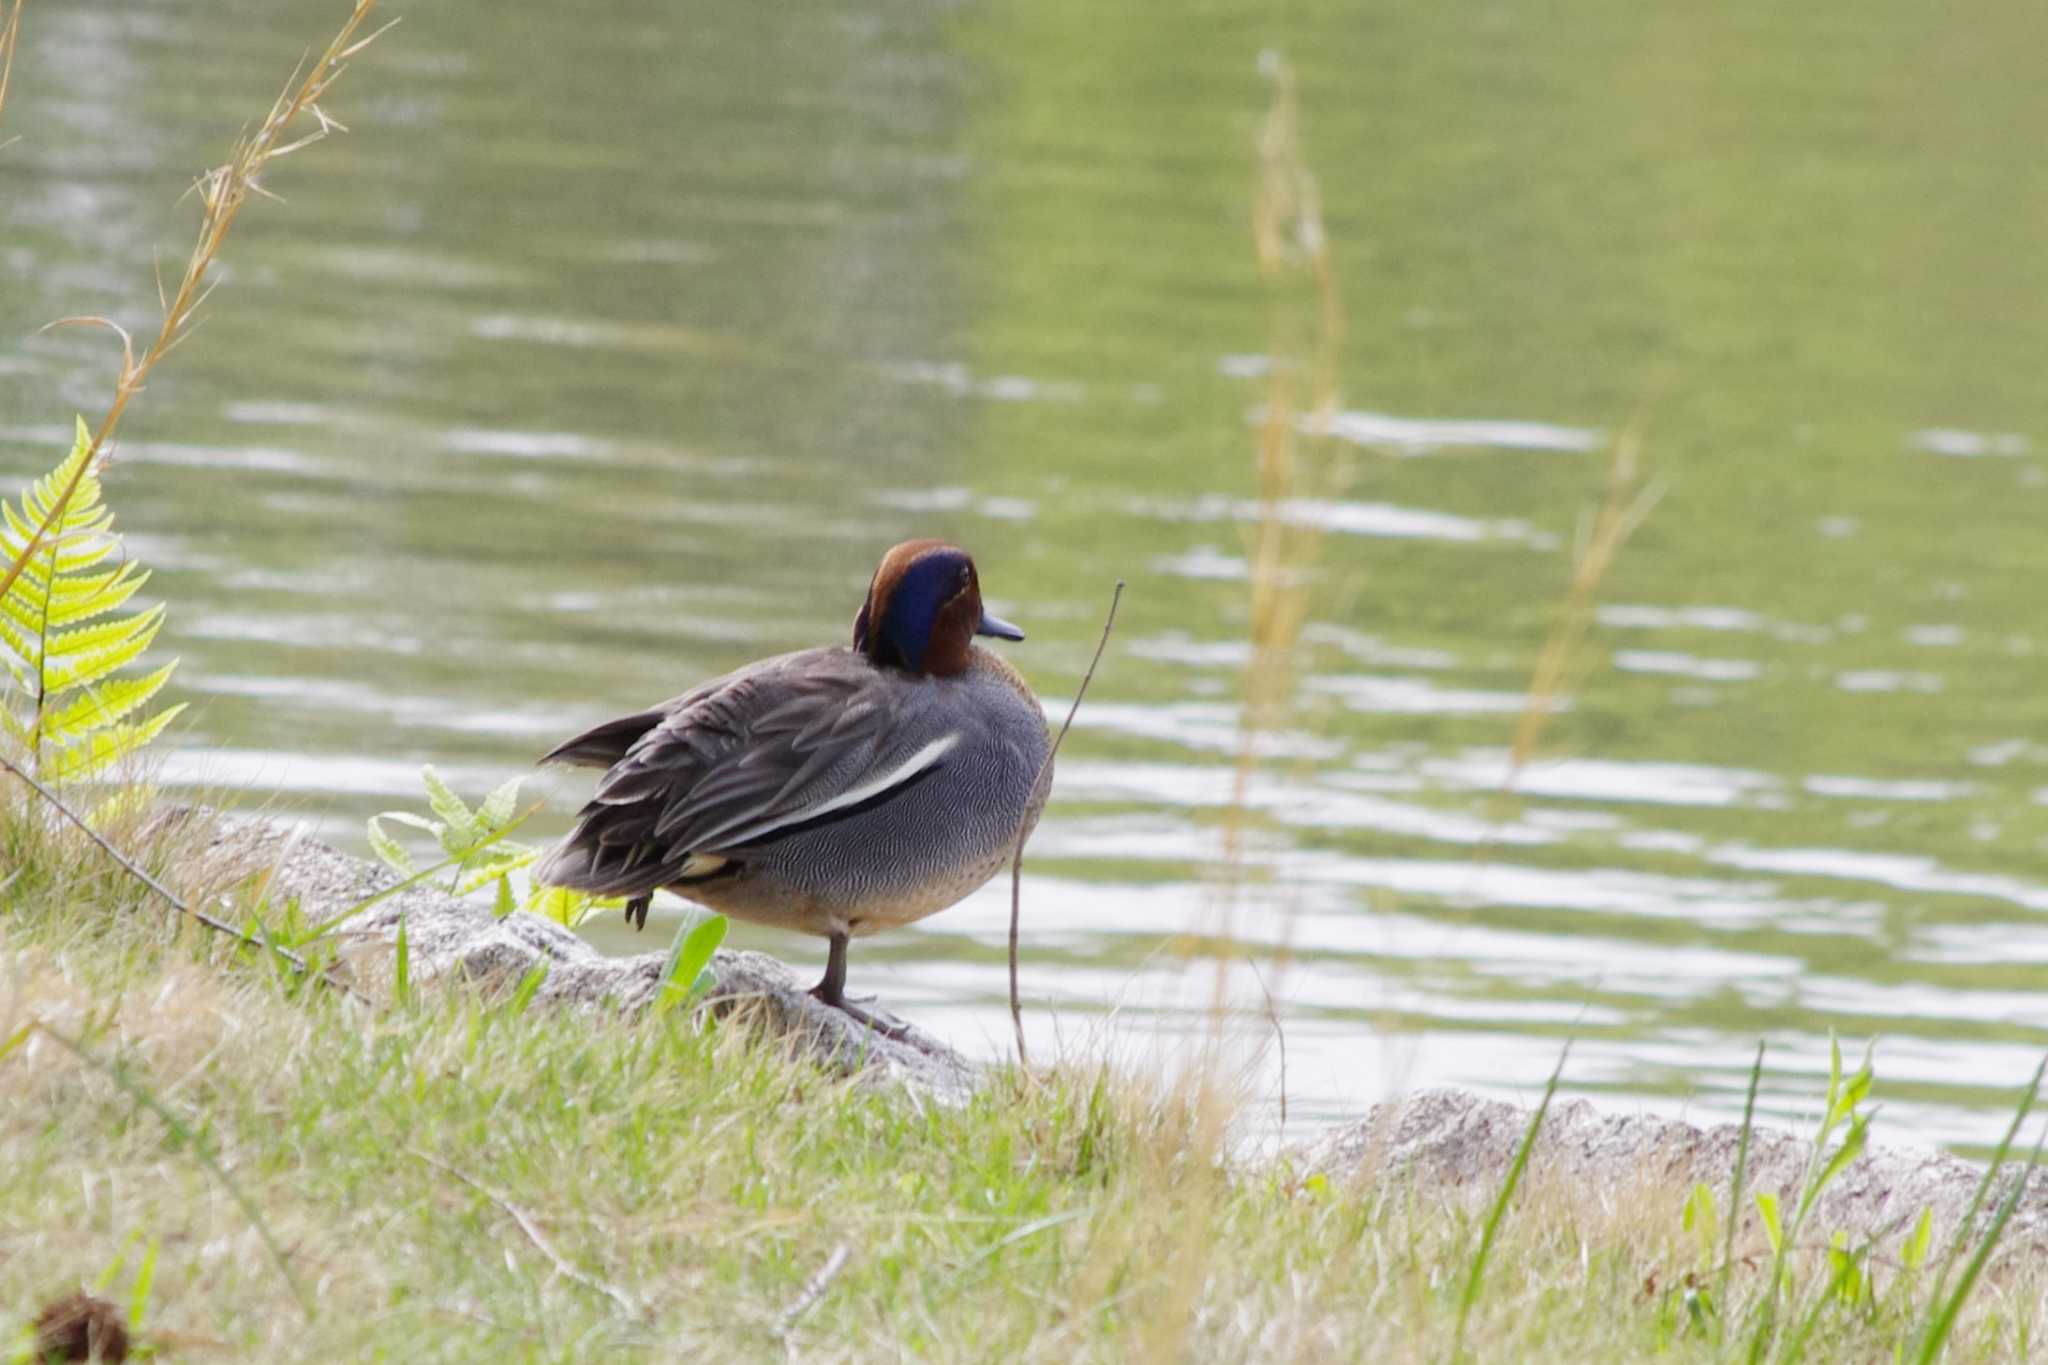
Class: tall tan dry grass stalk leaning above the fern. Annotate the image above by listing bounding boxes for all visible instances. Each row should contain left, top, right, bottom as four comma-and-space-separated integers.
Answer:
0, 0, 395, 609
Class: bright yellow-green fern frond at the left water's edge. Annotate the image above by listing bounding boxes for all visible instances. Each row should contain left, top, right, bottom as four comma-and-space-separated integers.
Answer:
0, 420, 184, 782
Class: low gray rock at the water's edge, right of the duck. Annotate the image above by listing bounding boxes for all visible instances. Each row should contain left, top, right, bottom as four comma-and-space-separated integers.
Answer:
1296, 1091, 2048, 1254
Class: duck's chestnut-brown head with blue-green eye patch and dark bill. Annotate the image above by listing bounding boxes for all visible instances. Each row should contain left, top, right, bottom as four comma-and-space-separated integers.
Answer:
854, 540, 1024, 677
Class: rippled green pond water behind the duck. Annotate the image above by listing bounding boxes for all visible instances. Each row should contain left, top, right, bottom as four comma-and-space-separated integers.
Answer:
0, 0, 2048, 1144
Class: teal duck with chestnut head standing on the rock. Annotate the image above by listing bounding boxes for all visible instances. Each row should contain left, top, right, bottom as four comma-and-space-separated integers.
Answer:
535, 540, 1053, 1038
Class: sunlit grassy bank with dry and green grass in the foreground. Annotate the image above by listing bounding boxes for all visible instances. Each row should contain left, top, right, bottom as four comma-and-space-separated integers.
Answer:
0, 875, 2040, 1361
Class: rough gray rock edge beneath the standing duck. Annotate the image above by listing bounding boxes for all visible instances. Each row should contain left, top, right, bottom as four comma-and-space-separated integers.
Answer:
201, 819, 975, 1099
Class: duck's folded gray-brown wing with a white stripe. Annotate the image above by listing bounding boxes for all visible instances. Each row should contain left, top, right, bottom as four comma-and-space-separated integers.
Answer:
543, 663, 961, 890
